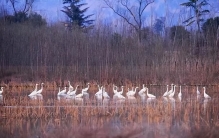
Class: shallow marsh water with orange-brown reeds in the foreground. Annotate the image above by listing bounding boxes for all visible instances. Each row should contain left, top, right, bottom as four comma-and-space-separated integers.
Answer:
0, 86, 219, 137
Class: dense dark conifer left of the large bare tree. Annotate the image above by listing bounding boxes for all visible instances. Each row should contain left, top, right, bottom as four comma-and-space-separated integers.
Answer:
61, 0, 94, 28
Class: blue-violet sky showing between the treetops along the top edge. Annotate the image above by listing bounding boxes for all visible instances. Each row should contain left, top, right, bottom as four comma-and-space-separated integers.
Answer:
0, 0, 219, 25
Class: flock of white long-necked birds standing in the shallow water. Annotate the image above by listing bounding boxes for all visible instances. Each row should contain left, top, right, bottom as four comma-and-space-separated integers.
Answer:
24, 81, 211, 99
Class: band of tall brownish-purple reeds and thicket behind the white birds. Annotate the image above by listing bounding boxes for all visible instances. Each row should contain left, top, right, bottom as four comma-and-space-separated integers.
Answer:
0, 23, 219, 84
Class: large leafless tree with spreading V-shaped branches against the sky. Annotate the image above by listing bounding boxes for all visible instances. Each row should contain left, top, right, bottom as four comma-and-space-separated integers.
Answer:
104, 0, 154, 41
